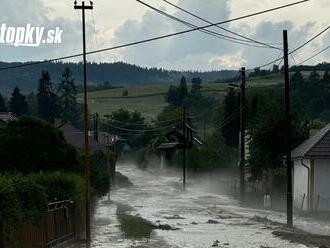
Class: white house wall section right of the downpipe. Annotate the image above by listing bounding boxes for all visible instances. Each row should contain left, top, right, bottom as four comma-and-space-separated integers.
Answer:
314, 159, 330, 211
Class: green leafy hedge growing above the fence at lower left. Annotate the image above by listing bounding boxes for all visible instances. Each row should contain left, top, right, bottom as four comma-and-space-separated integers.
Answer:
0, 172, 84, 223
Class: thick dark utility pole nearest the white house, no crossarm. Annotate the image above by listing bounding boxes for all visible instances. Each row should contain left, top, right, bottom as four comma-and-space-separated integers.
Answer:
283, 30, 293, 227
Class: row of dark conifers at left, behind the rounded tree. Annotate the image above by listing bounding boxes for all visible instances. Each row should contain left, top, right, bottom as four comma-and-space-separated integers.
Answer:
0, 67, 81, 126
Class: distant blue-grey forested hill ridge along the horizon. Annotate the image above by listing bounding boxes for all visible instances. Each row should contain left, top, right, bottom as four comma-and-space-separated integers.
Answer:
0, 62, 237, 94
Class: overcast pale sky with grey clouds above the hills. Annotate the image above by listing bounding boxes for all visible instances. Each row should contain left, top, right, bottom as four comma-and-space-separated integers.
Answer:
0, 0, 330, 70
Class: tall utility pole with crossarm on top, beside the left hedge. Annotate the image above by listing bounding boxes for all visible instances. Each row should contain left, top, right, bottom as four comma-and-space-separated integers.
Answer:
74, 1, 93, 243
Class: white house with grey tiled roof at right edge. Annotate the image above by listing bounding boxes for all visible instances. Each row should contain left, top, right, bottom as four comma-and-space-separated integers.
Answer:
291, 124, 330, 211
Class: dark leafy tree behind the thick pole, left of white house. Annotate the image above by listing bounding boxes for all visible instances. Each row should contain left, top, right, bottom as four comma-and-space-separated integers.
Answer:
248, 88, 310, 178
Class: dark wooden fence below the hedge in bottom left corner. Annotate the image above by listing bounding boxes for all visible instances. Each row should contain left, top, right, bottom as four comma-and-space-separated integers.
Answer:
0, 201, 76, 248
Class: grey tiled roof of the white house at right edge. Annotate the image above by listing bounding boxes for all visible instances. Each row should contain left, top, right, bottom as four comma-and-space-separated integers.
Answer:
291, 124, 330, 159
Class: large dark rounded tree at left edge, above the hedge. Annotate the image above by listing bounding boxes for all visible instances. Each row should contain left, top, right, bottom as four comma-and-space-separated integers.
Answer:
0, 117, 79, 174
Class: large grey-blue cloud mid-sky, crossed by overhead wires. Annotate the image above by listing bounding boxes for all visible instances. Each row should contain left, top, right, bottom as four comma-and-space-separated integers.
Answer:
114, 0, 233, 70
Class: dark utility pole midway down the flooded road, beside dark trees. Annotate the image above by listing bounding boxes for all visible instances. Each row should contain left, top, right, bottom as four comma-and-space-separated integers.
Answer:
240, 67, 246, 201
